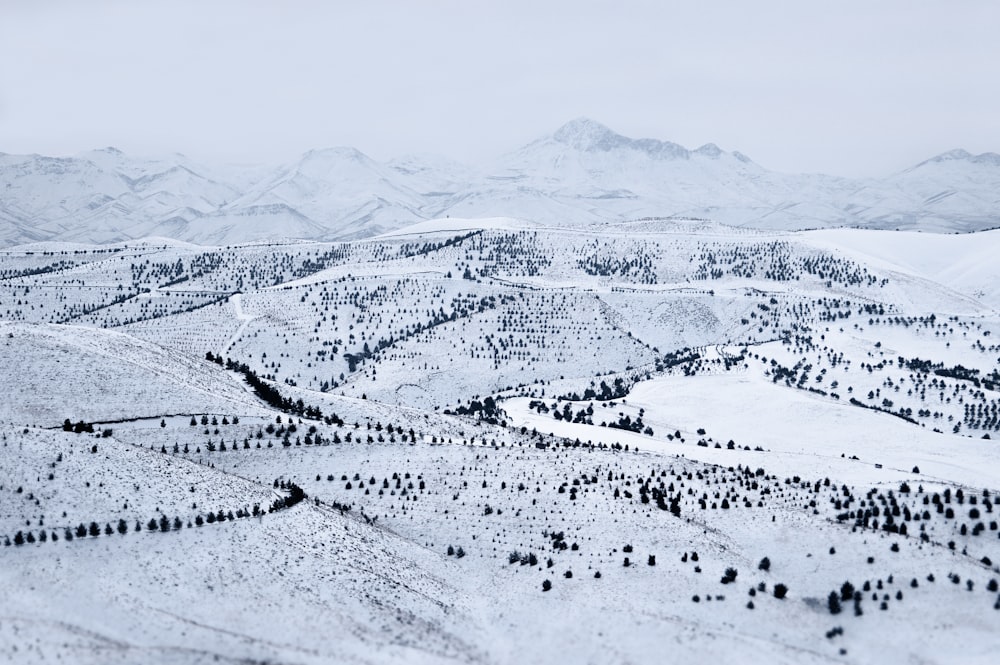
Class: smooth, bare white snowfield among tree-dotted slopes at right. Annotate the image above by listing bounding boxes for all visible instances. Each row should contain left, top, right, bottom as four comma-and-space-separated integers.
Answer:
504, 364, 1000, 488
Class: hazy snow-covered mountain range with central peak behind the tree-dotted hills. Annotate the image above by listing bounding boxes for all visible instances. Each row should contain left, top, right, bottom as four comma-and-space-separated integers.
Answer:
0, 118, 1000, 246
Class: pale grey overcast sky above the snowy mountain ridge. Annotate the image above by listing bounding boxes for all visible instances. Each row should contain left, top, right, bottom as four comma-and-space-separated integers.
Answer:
0, 0, 1000, 176
